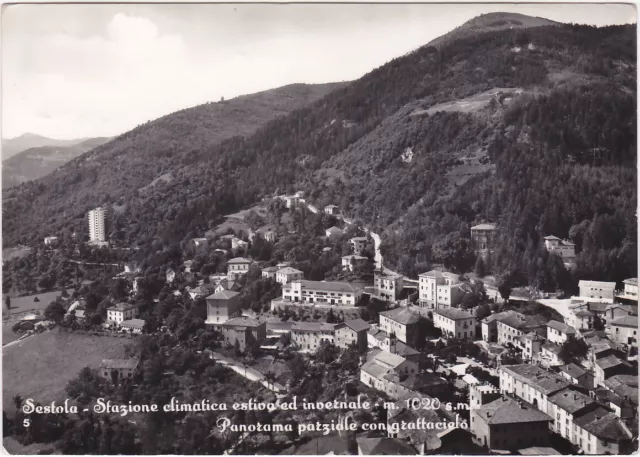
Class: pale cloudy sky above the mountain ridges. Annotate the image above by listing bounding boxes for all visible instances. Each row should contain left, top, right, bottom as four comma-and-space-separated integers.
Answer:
1, 3, 636, 139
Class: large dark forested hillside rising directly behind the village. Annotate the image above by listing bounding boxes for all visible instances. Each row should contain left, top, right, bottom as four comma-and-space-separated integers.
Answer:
3, 16, 637, 290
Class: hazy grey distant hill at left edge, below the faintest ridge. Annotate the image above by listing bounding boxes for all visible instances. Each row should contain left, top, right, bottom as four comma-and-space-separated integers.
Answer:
2, 138, 110, 188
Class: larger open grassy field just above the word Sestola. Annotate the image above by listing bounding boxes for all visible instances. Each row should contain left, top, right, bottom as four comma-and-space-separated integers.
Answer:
2, 330, 135, 412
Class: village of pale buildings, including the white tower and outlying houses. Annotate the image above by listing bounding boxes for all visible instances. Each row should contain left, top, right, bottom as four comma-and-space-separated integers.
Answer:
3, 188, 638, 455
